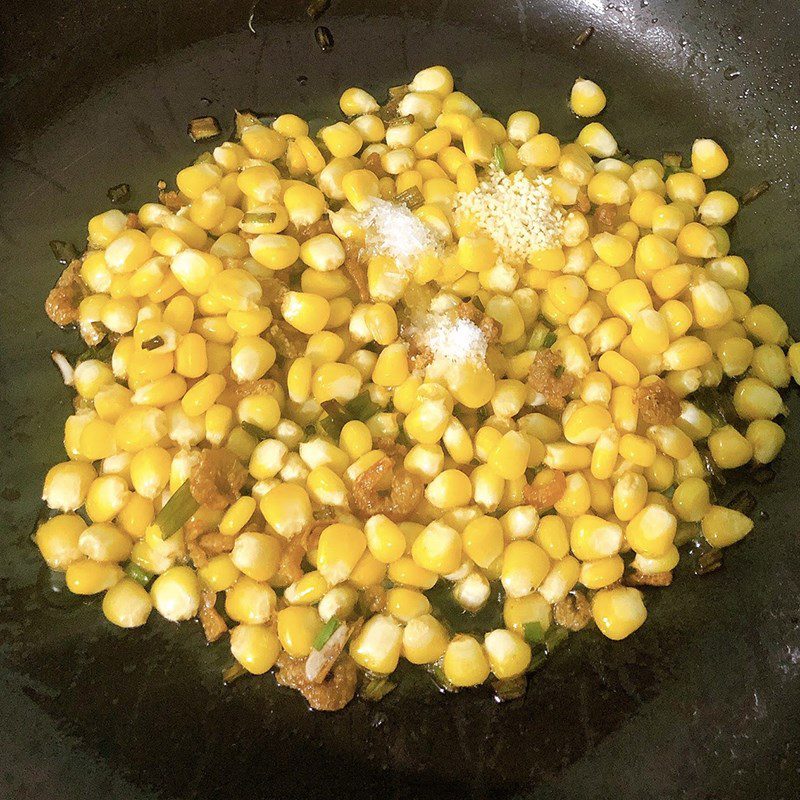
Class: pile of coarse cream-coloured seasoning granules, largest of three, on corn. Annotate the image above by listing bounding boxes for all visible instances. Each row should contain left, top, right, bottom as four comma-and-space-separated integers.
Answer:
455, 167, 565, 267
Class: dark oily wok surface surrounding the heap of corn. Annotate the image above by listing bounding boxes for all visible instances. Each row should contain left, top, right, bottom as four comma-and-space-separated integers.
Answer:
0, 0, 800, 800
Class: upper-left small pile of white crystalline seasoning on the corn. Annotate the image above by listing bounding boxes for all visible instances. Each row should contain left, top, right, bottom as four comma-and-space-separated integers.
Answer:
360, 200, 440, 270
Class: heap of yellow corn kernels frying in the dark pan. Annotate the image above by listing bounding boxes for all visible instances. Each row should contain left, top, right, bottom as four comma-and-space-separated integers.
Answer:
35, 67, 800, 707
